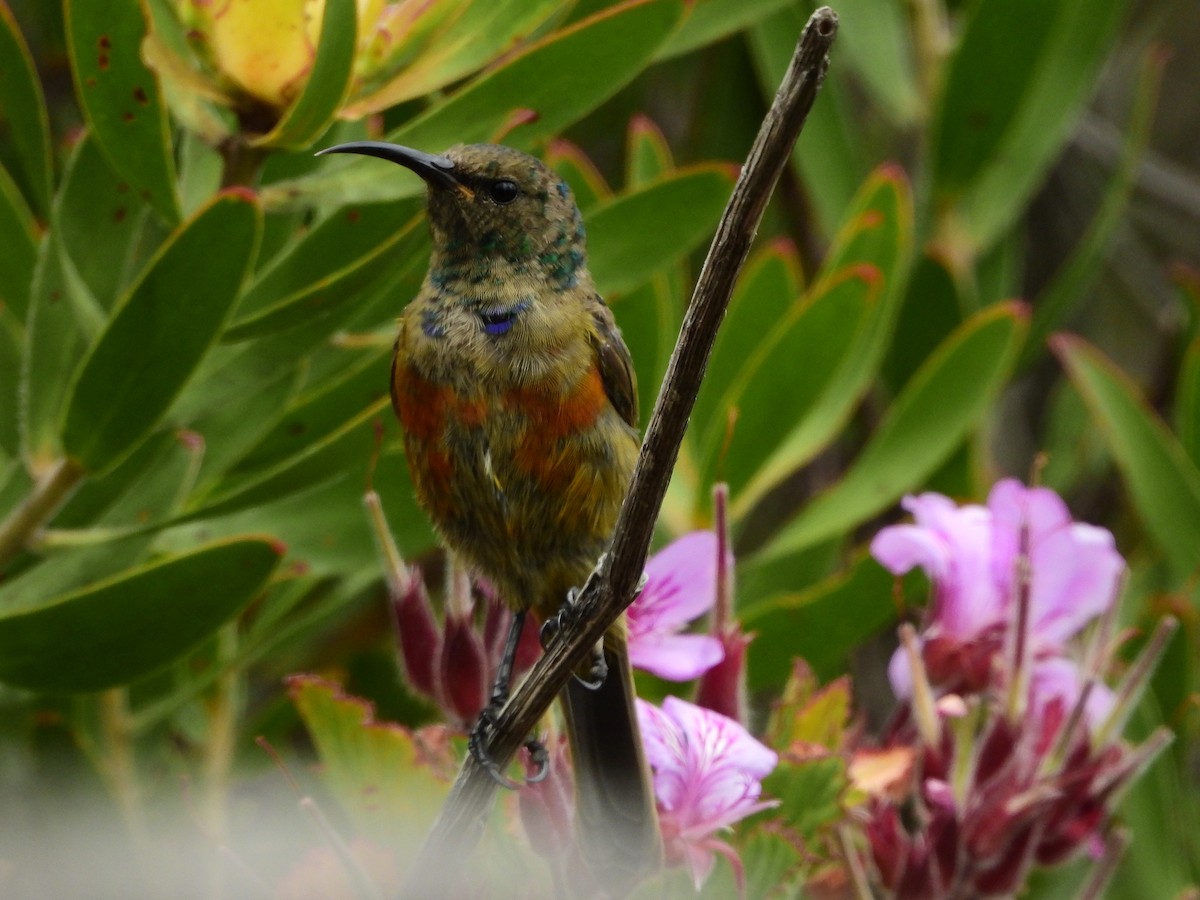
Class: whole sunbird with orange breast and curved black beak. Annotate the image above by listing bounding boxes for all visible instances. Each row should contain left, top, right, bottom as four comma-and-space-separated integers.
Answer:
322, 140, 662, 893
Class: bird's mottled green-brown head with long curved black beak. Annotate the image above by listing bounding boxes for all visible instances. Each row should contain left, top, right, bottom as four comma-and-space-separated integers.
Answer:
322, 140, 586, 288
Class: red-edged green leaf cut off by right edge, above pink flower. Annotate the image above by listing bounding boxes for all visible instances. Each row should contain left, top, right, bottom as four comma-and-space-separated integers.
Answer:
1050, 335, 1200, 586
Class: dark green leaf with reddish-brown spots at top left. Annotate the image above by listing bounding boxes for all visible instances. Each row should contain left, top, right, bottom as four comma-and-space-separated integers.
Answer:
65, 0, 180, 224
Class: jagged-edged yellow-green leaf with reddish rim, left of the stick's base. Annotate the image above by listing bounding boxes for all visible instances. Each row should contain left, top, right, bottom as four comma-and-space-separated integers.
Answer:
288, 676, 454, 853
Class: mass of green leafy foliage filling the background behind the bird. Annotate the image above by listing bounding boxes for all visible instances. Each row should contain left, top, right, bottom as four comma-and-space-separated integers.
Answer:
0, 0, 1200, 898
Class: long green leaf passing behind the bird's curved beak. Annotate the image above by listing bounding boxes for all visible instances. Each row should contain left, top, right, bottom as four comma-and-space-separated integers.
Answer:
263, 0, 683, 209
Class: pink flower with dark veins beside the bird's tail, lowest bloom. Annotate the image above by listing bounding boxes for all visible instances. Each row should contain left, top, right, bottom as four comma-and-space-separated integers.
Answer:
637, 697, 779, 889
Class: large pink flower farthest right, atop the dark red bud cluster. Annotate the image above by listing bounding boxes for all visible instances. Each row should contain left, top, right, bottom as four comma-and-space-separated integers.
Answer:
871, 479, 1124, 721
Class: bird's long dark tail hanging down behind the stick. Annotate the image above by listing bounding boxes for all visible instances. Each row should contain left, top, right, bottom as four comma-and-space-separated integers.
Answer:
562, 634, 662, 896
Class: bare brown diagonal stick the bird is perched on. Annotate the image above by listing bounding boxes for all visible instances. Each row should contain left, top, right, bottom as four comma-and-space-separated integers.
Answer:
404, 7, 838, 896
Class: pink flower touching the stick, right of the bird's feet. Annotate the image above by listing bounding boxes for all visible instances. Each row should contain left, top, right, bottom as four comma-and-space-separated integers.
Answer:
626, 532, 725, 682
